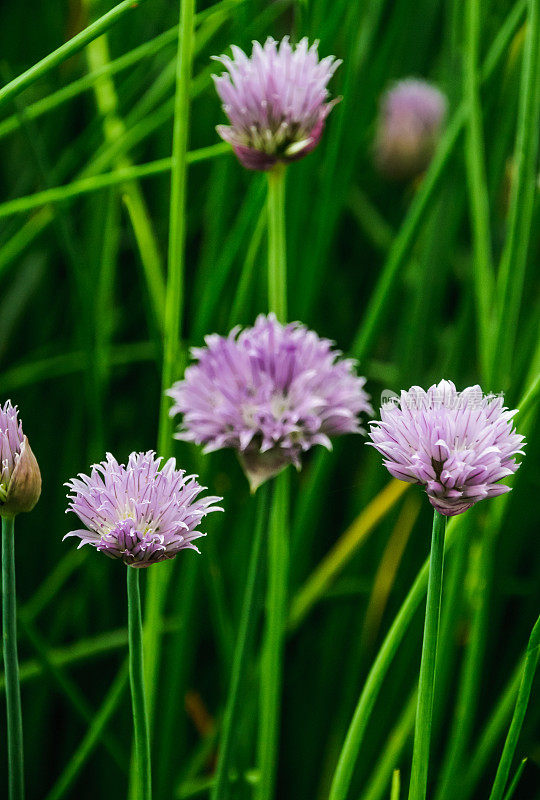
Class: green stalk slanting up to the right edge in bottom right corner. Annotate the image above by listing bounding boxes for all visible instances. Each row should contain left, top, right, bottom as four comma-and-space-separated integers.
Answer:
489, 617, 540, 800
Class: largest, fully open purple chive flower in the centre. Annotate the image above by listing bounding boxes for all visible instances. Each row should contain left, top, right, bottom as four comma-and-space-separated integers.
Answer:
168, 314, 371, 491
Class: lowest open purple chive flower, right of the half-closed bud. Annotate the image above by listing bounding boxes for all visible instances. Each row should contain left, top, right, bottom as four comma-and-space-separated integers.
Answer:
64, 451, 223, 567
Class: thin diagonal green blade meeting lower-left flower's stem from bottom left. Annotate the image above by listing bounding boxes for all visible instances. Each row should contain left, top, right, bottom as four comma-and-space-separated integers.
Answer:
45, 662, 128, 800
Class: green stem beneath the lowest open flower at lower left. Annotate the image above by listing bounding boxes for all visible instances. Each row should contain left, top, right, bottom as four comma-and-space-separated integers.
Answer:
127, 567, 152, 800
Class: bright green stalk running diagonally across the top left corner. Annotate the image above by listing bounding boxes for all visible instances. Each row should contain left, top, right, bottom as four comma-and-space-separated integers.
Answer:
0, 0, 150, 107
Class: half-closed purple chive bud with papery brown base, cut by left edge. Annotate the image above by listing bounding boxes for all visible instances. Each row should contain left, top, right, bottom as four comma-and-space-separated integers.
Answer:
0, 400, 41, 517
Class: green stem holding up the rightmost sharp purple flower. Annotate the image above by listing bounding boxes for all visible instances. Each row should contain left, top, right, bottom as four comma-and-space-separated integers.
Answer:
409, 511, 446, 800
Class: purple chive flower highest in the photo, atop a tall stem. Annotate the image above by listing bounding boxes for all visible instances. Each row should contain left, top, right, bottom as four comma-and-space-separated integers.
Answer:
214, 36, 341, 170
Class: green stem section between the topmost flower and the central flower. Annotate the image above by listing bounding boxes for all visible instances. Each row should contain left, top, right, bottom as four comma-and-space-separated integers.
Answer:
268, 164, 287, 322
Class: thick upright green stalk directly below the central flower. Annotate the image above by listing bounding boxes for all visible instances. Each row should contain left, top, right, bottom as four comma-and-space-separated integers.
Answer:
256, 471, 289, 800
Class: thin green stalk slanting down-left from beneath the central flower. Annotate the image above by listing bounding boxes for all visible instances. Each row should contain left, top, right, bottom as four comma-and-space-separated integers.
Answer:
210, 484, 269, 800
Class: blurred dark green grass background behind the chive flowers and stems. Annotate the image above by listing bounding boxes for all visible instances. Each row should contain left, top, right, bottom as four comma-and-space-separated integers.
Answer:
0, 0, 540, 800
